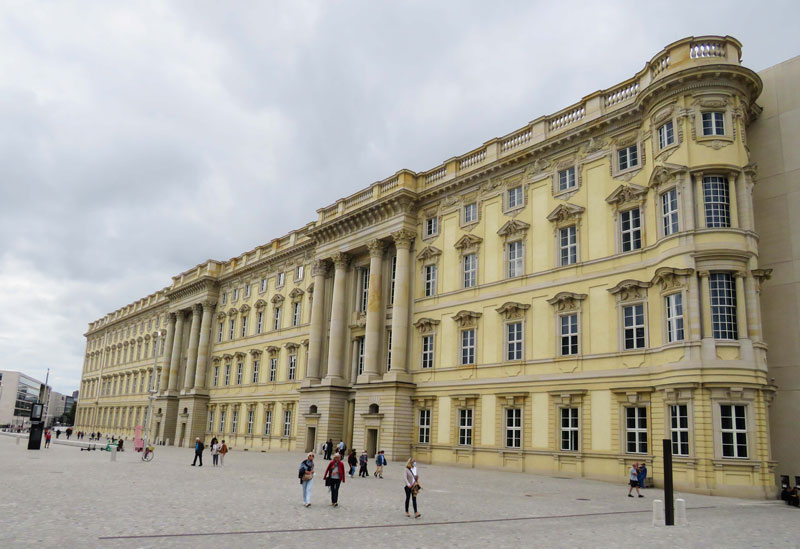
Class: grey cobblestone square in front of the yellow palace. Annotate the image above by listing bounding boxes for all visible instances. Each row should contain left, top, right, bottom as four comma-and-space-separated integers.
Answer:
0, 436, 800, 548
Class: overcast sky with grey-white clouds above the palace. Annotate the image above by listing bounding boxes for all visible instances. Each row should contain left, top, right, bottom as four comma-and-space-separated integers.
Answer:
0, 0, 800, 392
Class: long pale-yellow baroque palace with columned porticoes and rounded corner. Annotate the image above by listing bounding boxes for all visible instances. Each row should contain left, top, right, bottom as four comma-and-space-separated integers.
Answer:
76, 36, 776, 497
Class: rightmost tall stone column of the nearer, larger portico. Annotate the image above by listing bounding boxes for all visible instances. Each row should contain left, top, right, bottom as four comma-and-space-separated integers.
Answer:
384, 229, 415, 379
